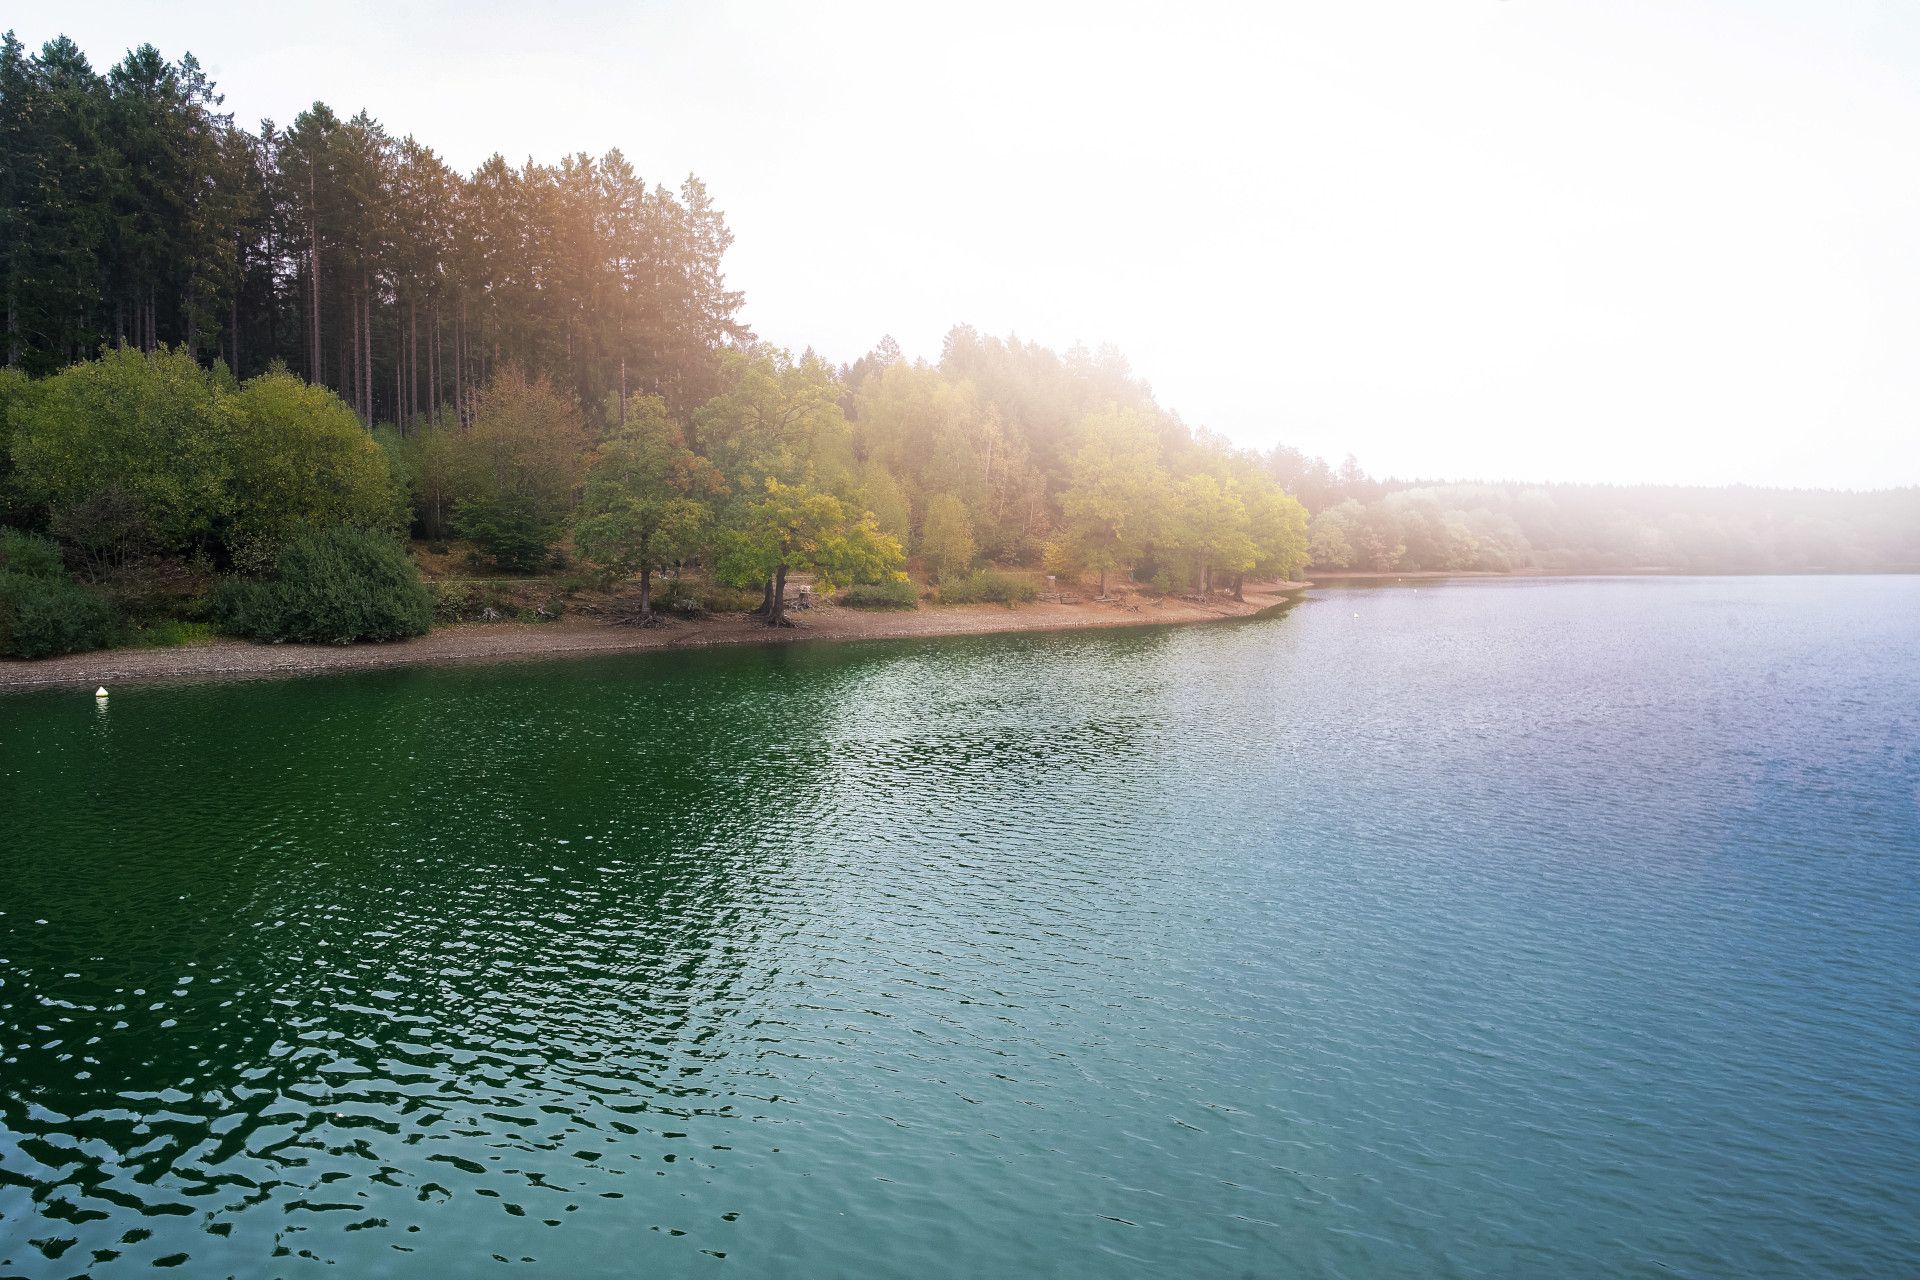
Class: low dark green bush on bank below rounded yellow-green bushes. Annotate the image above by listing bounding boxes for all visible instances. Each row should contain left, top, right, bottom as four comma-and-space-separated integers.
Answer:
213, 526, 434, 645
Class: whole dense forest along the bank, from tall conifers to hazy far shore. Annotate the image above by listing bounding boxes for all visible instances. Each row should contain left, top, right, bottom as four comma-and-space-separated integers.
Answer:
0, 33, 1920, 652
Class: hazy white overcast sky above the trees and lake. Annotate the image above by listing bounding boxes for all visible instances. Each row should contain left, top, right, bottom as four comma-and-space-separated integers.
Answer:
18, 0, 1920, 487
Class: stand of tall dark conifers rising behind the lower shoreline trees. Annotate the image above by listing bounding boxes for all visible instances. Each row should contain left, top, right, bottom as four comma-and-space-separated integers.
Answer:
0, 33, 747, 420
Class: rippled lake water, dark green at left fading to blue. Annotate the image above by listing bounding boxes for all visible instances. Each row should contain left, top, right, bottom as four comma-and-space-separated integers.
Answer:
0, 578, 1920, 1278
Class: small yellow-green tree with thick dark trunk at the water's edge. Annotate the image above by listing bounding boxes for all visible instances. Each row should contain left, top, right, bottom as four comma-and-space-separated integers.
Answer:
720, 480, 906, 628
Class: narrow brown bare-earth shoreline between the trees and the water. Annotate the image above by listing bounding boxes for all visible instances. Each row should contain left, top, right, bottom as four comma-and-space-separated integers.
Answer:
0, 581, 1311, 695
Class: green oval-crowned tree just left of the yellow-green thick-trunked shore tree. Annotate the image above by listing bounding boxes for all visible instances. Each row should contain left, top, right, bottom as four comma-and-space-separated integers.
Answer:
574, 395, 724, 626
